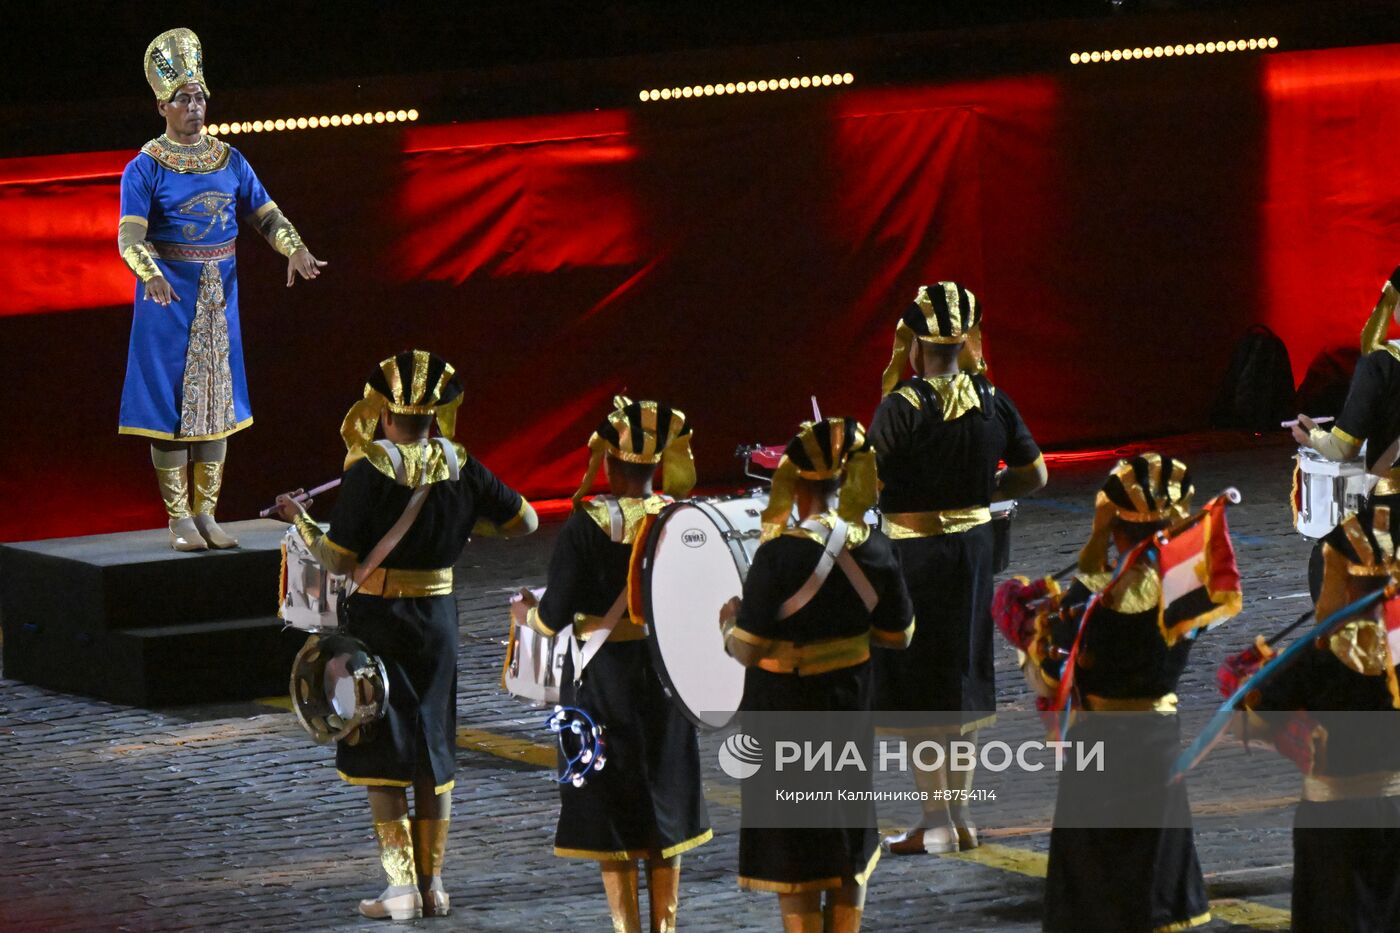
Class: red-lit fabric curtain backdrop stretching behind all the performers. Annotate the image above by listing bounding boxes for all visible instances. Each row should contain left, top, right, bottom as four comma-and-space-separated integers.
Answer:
0, 48, 1400, 539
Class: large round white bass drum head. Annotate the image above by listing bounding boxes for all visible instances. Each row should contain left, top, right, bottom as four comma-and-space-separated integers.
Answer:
641, 503, 759, 730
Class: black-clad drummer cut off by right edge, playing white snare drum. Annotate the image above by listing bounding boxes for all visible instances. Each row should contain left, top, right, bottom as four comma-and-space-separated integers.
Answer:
1294, 268, 1400, 509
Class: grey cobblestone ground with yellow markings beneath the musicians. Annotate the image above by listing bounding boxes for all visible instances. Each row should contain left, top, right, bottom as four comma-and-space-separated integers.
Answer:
0, 436, 1310, 933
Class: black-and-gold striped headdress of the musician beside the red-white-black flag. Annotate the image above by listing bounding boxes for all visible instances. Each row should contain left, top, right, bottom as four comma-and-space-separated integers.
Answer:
1079, 452, 1196, 574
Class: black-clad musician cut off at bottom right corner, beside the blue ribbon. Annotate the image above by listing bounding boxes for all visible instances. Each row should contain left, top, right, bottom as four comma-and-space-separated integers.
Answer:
1218, 506, 1400, 933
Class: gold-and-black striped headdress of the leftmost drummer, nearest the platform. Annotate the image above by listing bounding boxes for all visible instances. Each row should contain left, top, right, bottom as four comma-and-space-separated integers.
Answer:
340, 350, 462, 469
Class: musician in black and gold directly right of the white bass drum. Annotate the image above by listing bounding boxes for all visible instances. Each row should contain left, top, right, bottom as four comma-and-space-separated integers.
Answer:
721, 417, 914, 933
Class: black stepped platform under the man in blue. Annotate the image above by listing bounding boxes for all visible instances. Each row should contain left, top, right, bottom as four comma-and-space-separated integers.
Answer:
0, 520, 305, 706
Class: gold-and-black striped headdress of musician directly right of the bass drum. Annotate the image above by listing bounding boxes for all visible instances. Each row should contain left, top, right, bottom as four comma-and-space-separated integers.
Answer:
763, 417, 876, 541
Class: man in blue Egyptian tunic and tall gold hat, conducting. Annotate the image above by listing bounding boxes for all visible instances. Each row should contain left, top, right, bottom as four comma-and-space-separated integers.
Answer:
118, 29, 326, 551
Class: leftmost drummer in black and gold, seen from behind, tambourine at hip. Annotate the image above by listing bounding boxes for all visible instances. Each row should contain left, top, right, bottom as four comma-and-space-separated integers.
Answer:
277, 350, 538, 919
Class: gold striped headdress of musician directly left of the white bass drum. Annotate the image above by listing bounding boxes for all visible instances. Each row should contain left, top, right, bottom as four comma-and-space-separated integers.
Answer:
574, 395, 696, 506
